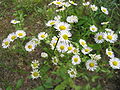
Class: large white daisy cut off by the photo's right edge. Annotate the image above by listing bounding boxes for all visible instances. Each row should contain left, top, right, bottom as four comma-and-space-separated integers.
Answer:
109, 57, 120, 69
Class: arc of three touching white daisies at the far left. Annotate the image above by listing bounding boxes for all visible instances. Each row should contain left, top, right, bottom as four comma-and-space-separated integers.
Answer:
2, 30, 26, 48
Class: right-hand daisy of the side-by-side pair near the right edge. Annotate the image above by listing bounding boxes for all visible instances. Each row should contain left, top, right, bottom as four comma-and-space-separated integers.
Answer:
104, 33, 118, 43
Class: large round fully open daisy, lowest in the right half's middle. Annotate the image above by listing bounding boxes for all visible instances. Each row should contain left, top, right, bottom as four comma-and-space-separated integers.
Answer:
86, 60, 98, 71
